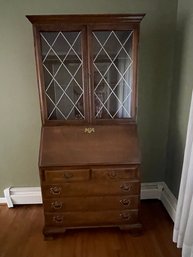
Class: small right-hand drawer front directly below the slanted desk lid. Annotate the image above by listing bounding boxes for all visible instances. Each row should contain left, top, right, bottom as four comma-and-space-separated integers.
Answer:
92, 166, 139, 181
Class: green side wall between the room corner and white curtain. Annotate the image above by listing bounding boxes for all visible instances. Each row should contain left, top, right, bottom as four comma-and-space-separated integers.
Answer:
165, 0, 193, 197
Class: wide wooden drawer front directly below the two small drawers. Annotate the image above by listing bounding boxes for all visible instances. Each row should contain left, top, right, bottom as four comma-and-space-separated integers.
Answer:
42, 180, 140, 198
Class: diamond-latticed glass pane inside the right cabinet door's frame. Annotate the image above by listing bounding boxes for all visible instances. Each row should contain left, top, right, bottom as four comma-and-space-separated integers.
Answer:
92, 30, 133, 119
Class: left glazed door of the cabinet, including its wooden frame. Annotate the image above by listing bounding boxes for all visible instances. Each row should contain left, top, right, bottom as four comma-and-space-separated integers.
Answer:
35, 25, 88, 123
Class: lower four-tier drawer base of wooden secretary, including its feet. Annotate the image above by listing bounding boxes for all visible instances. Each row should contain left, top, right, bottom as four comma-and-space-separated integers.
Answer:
40, 162, 140, 236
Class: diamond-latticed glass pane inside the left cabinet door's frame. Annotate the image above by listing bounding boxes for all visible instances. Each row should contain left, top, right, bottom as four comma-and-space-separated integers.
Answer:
40, 31, 85, 120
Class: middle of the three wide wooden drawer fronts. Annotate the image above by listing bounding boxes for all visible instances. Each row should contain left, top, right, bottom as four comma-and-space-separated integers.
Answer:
44, 196, 139, 212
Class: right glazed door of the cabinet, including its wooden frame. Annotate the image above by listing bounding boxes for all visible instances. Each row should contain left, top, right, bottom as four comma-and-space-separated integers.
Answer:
90, 25, 138, 123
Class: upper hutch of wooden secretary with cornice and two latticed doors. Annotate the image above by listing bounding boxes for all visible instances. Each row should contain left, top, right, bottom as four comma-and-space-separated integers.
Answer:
27, 14, 144, 125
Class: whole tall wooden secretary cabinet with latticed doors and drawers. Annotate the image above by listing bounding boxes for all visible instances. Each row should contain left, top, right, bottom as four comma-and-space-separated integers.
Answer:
27, 14, 144, 235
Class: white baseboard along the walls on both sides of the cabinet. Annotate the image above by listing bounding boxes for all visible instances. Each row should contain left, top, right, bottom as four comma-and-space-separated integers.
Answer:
0, 182, 177, 221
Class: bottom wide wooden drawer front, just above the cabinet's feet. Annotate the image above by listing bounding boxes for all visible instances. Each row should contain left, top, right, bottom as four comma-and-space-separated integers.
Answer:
45, 210, 138, 227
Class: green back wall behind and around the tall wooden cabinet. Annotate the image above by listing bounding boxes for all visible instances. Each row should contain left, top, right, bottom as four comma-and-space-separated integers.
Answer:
0, 0, 177, 197
